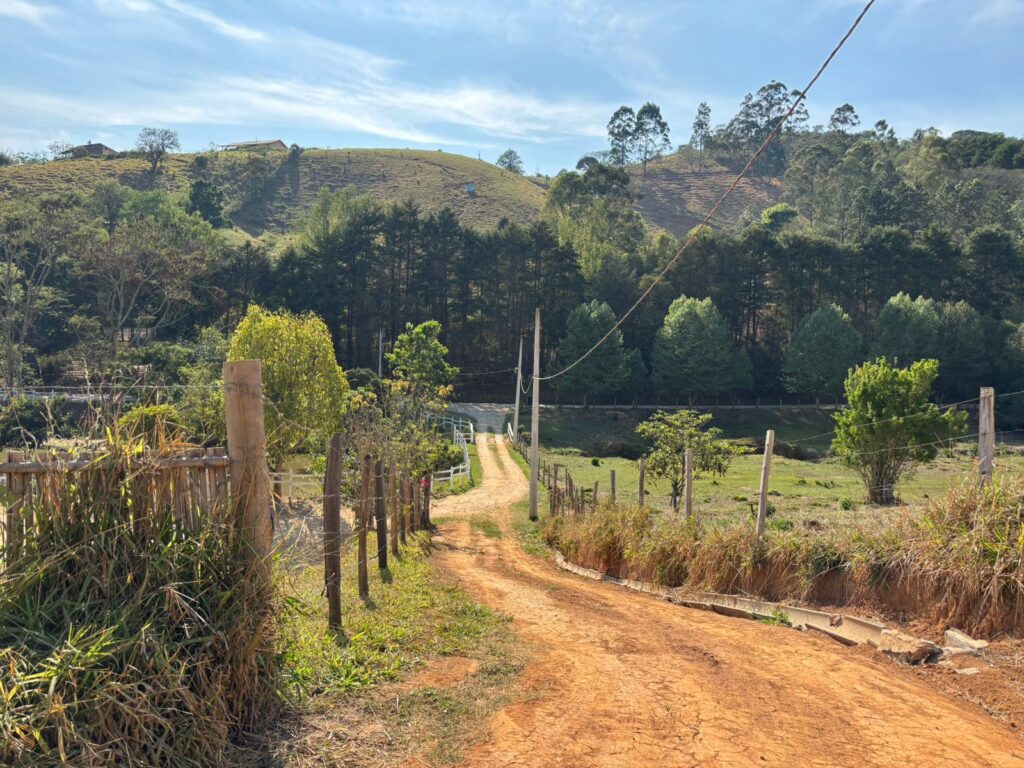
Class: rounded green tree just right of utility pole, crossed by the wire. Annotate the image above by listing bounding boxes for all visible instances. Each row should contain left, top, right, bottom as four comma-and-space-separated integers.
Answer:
555, 299, 626, 406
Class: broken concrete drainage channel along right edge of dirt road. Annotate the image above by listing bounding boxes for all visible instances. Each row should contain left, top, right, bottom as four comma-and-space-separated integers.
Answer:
555, 552, 988, 674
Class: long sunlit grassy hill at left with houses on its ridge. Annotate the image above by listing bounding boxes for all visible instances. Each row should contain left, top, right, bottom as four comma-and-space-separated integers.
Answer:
0, 150, 545, 236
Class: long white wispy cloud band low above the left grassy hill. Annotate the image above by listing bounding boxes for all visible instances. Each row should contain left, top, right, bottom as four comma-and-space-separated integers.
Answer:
0, 67, 608, 145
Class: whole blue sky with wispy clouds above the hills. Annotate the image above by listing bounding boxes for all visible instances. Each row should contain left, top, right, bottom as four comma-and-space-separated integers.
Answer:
0, 0, 1024, 173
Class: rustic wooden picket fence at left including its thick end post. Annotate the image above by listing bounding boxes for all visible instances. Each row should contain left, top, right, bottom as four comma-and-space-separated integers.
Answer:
0, 360, 272, 575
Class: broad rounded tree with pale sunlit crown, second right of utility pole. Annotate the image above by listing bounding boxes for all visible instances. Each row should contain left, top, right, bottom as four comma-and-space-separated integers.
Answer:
651, 296, 752, 402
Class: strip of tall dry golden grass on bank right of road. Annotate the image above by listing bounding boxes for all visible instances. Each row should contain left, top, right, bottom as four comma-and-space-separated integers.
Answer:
542, 478, 1024, 634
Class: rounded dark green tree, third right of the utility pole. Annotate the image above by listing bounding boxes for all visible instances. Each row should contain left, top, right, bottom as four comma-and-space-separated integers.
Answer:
782, 304, 864, 402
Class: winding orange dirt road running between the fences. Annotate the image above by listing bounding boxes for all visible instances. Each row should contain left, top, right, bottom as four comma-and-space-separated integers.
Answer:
435, 437, 1024, 768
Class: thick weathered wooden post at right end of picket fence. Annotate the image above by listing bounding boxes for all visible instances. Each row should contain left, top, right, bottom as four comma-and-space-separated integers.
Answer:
223, 360, 273, 579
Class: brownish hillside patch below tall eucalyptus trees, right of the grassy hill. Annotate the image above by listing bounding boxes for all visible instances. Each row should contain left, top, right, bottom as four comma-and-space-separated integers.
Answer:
630, 154, 782, 236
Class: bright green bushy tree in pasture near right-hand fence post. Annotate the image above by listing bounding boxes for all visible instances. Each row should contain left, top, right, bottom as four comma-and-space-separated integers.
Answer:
831, 357, 967, 505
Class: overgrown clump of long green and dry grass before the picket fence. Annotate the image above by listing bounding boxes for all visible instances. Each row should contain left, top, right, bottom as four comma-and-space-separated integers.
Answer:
0, 447, 276, 768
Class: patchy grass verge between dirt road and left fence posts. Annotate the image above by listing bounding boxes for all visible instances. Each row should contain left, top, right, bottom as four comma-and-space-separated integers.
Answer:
278, 531, 522, 768
